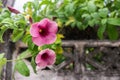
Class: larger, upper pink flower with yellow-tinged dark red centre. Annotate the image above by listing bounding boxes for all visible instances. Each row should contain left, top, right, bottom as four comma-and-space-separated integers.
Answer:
30, 18, 58, 46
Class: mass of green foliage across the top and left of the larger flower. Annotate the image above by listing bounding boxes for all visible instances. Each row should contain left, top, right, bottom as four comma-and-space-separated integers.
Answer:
0, 0, 120, 43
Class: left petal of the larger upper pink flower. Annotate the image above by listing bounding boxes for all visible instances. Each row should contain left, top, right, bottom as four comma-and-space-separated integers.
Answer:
30, 22, 39, 37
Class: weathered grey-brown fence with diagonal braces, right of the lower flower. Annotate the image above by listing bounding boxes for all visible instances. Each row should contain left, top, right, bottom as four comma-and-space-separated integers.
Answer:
11, 40, 120, 80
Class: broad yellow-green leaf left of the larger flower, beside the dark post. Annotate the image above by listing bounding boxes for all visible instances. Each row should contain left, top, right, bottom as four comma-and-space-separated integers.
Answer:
12, 29, 24, 42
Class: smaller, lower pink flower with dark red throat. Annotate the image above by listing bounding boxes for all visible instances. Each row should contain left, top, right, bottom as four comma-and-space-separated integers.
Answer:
35, 49, 56, 69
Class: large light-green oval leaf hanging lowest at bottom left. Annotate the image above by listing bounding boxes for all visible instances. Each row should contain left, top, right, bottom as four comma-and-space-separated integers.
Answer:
15, 60, 30, 76
